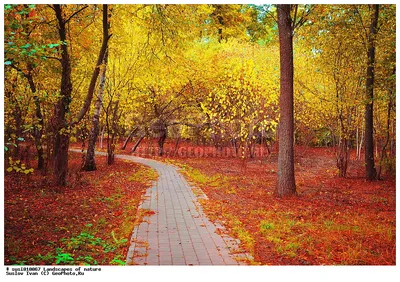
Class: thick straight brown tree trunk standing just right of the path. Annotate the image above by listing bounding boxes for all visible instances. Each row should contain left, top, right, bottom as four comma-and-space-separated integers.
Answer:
276, 4, 296, 197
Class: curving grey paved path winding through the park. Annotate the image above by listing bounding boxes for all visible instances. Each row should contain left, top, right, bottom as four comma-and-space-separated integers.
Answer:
72, 152, 250, 265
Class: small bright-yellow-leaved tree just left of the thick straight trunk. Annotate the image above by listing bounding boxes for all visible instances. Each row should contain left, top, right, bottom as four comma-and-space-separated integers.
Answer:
195, 44, 277, 157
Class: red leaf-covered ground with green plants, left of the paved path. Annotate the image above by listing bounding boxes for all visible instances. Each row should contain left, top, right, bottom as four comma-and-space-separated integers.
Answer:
5, 154, 153, 264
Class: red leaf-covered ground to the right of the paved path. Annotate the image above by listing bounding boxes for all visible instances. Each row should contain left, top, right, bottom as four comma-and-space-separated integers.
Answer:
165, 148, 396, 265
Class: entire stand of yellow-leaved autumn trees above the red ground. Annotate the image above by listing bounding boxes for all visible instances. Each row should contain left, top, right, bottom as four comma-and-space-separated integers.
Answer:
4, 4, 396, 185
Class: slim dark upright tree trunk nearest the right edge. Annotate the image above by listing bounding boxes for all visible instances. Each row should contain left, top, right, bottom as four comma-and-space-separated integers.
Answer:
365, 5, 379, 180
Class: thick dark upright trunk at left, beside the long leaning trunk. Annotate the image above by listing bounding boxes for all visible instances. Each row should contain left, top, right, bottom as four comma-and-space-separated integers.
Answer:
53, 4, 72, 186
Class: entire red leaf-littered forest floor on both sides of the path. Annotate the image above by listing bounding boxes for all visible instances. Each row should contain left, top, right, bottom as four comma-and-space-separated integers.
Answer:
5, 142, 396, 265
